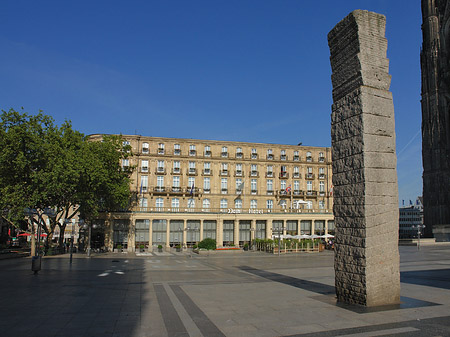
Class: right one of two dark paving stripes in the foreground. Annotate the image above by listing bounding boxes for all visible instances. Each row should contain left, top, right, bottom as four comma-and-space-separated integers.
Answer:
171, 285, 225, 337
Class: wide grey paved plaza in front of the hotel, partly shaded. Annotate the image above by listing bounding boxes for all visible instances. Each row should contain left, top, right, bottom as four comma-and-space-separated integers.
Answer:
0, 244, 450, 337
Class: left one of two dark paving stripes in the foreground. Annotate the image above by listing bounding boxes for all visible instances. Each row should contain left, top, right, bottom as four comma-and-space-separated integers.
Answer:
153, 284, 189, 337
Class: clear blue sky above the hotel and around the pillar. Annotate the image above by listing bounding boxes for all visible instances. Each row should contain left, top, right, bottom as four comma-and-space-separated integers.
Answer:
0, 0, 422, 203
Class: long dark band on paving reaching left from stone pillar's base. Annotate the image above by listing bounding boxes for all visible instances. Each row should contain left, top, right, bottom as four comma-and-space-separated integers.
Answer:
238, 266, 336, 295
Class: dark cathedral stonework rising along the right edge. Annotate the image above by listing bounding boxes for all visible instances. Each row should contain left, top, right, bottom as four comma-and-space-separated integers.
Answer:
420, 0, 450, 241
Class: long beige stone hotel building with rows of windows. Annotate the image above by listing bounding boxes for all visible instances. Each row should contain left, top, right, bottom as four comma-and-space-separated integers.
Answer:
91, 135, 334, 251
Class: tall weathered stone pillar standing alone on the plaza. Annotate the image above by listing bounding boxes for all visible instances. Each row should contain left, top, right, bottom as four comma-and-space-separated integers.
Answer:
328, 10, 400, 306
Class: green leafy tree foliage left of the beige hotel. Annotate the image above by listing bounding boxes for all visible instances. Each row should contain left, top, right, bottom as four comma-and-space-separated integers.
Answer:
0, 109, 131, 247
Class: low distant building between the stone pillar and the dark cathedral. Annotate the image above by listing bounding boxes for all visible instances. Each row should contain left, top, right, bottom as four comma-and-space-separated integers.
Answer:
398, 197, 423, 239
